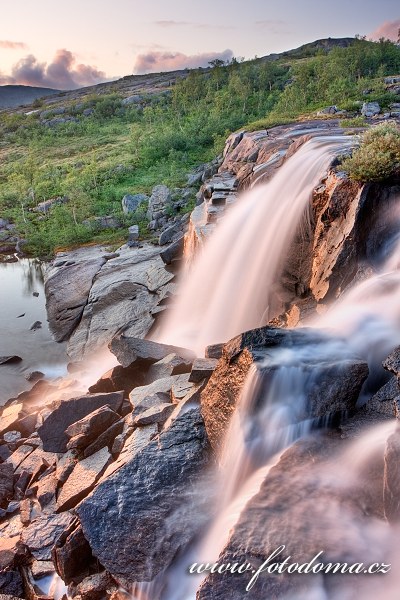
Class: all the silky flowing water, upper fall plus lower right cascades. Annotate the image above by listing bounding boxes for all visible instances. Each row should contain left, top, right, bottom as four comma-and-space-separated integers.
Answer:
138, 138, 400, 600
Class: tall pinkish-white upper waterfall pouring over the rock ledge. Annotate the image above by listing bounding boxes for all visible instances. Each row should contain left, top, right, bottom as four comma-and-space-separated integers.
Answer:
157, 136, 353, 355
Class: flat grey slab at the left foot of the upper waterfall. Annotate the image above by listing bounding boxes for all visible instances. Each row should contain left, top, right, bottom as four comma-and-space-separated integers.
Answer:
109, 335, 195, 367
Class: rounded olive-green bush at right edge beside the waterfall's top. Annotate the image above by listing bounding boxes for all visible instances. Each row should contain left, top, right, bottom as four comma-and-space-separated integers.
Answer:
341, 122, 400, 182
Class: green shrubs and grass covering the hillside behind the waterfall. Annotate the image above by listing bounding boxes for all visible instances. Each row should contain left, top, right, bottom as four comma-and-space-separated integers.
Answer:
0, 39, 400, 254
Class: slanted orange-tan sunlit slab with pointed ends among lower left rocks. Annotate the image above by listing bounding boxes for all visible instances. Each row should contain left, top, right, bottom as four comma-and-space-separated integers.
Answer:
57, 448, 111, 512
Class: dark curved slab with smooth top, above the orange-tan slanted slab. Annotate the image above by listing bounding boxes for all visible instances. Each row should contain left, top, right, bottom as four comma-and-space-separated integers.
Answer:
38, 392, 123, 452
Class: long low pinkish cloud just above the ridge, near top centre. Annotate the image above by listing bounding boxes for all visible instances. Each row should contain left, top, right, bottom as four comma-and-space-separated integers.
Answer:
134, 49, 233, 74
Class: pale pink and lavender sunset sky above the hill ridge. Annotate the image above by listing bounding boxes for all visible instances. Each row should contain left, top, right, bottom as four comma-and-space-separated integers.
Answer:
0, 0, 400, 89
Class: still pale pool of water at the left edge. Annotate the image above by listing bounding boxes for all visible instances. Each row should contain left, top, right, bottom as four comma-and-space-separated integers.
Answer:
0, 259, 67, 405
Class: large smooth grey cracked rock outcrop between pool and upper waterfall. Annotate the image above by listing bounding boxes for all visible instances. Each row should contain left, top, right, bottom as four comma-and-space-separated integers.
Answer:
45, 245, 174, 360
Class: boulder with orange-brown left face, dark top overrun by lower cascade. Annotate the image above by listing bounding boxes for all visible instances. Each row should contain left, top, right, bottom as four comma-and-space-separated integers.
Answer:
201, 327, 368, 451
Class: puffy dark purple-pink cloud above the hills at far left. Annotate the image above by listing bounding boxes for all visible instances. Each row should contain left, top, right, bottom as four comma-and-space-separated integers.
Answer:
0, 50, 106, 90
